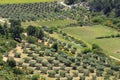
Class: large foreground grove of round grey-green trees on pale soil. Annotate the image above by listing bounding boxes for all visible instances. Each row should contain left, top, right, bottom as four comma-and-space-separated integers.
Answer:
3, 28, 120, 80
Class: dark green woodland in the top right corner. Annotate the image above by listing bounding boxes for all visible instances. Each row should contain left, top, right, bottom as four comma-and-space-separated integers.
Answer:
65, 0, 120, 17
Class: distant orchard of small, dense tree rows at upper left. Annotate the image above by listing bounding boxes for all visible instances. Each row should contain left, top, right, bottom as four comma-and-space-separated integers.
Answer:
0, 1, 62, 21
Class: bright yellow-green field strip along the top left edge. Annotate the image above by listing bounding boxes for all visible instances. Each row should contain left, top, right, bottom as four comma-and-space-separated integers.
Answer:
0, 0, 55, 4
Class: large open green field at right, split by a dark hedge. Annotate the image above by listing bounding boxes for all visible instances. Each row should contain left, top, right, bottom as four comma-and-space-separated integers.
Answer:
63, 25, 120, 59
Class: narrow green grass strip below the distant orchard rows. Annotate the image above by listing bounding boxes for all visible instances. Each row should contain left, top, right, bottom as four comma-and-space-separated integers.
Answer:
22, 19, 75, 28
